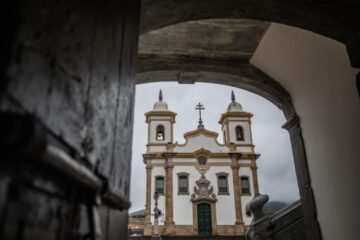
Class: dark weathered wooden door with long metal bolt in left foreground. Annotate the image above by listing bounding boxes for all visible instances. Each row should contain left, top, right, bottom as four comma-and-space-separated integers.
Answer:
0, 0, 140, 239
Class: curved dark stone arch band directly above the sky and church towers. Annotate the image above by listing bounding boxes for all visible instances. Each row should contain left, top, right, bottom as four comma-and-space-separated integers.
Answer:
136, 59, 296, 120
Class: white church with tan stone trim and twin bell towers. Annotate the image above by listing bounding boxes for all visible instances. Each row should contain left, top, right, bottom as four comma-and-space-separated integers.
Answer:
143, 90, 259, 236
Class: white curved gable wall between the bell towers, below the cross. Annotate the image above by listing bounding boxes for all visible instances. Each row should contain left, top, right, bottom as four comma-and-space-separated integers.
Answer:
174, 134, 229, 152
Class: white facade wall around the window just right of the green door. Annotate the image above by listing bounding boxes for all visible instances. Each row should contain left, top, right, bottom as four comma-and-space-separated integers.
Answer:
206, 166, 236, 225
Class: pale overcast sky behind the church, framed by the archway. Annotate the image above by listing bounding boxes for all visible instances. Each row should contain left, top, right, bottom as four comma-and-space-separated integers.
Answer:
130, 82, 299, 212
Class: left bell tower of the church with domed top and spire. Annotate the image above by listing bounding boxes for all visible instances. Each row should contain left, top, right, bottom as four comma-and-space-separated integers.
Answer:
145, 90, 176, 152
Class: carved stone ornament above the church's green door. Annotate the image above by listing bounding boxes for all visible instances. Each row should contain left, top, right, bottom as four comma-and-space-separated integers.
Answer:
191, 172, 217, 202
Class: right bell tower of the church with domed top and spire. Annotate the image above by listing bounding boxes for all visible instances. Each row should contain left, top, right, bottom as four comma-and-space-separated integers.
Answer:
219, 91, 254, 152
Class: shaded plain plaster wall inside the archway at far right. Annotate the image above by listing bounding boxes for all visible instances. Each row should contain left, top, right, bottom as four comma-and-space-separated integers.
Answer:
251, 24, 360, 240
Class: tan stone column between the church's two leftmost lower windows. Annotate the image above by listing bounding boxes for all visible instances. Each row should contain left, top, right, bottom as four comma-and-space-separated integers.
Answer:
164, 154, 175, 235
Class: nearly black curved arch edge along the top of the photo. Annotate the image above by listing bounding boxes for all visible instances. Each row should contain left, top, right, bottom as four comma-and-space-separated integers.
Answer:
140, 0, 360, 44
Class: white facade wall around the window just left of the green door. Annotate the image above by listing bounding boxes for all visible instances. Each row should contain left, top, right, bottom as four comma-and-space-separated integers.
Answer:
173, 166, 200, 225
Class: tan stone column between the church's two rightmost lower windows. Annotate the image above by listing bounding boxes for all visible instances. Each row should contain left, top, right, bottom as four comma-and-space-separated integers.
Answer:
231, 155, 245, 235
